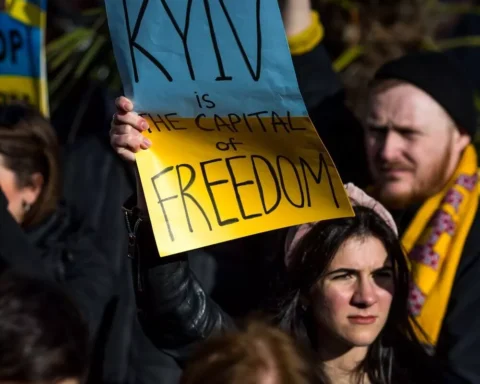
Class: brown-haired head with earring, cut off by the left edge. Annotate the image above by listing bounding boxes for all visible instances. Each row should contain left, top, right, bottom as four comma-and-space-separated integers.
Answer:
0, 104, 61, 227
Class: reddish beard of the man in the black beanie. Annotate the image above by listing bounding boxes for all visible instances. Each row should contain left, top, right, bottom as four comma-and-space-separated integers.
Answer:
376, 147, 451, 209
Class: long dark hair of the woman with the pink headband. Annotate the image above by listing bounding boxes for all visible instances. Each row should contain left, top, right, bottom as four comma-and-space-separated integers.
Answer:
272, 206, 436, 384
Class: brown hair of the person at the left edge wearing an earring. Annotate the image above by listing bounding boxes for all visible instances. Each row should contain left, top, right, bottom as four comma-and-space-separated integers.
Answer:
0, 104, 62, 227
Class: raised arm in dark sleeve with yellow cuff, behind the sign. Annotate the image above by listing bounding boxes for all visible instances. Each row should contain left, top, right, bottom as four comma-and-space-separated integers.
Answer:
282, 0, 371, 188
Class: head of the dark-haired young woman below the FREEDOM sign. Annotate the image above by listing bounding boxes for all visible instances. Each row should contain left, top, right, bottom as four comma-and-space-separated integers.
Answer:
274, 206, 424, 382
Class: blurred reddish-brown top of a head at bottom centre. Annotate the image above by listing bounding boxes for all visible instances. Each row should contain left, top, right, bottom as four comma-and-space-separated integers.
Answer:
180, 322, 313, 384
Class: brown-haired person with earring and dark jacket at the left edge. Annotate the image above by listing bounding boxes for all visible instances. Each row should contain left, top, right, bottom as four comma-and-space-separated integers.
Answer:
0, 105, 113, 382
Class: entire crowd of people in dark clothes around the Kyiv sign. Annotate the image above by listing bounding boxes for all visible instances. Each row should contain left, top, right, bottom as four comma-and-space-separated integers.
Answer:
0, 0, 480, 384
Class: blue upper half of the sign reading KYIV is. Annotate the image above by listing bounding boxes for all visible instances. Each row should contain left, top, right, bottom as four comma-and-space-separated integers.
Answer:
106, 0, 307, 117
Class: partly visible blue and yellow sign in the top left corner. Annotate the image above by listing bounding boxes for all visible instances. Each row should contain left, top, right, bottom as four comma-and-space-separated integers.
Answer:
0, 0, 49, 116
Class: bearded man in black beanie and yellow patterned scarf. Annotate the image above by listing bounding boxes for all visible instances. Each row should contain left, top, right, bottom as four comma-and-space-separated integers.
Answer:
365, 53, 480, 383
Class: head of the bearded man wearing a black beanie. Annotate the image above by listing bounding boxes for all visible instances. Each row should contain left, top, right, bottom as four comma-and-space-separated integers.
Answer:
365, 52, 476, 208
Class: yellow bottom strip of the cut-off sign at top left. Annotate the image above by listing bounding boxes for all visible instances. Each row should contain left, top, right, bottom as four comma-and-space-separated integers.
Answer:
0, 75, 49, 117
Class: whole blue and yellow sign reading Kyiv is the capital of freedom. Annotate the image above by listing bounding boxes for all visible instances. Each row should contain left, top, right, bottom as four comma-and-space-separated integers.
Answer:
106, 0, 353, 256
